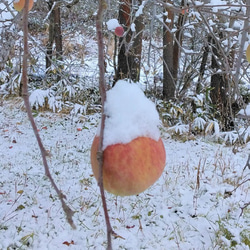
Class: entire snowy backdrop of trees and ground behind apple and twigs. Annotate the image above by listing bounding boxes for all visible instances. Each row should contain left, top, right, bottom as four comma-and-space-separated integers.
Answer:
0, 0, 250, 249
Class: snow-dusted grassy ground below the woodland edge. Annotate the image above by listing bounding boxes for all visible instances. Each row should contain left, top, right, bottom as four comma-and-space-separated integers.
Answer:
0, 100, 250, 250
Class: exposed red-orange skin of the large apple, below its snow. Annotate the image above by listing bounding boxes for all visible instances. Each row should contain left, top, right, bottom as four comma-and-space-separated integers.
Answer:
91, 136, 166, 196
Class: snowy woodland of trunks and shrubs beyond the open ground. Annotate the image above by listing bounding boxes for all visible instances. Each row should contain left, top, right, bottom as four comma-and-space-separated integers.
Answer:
0, 0, 250, 143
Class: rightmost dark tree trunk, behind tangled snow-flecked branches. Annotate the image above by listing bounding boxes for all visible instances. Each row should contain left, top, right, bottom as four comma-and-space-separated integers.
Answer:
192, 1, 247, 131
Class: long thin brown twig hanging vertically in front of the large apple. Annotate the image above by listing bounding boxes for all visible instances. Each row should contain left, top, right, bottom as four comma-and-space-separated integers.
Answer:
96, 0, 114, 250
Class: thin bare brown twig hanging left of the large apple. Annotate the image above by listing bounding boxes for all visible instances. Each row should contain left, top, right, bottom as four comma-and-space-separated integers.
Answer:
22, 0, 76, 229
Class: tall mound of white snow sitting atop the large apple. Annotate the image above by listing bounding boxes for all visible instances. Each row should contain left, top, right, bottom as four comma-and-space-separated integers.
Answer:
103, 80, 160, 149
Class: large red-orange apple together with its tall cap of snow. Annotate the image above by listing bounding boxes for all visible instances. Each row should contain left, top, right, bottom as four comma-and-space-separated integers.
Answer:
91, 80, 166, 196
